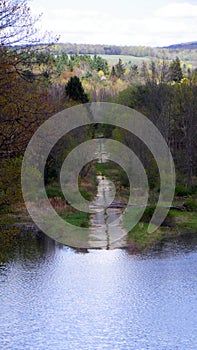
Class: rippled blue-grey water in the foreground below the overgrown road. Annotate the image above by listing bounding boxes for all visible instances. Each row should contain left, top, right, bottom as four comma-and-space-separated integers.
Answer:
0, 234, 197, 350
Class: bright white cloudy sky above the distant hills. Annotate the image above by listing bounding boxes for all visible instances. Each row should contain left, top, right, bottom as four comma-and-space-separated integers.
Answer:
29, 0, 197, 47
